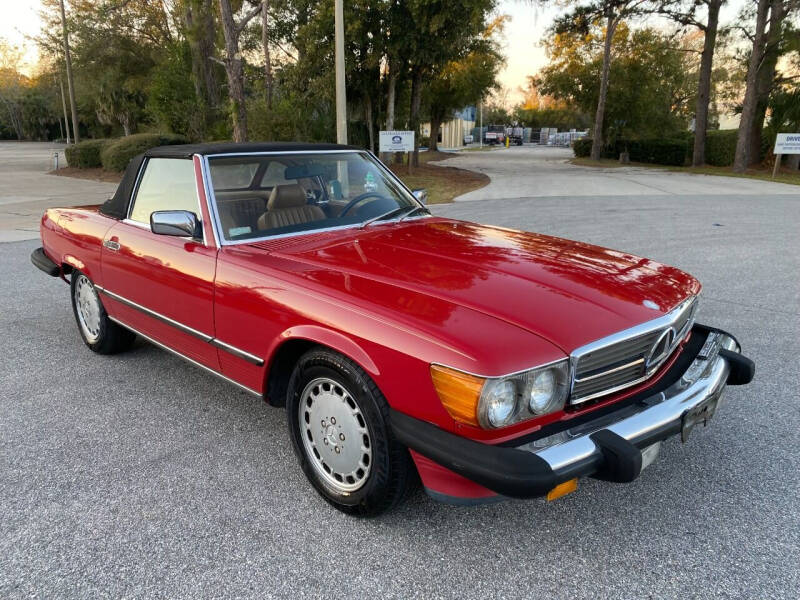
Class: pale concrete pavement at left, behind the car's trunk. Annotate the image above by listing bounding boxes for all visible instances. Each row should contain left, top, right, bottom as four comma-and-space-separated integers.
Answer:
0, 142, 117, 242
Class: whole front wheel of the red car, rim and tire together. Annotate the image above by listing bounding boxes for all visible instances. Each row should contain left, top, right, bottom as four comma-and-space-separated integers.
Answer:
286, 349, 414, 517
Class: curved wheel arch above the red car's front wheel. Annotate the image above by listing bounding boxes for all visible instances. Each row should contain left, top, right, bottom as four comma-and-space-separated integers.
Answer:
264, 325, 380, 406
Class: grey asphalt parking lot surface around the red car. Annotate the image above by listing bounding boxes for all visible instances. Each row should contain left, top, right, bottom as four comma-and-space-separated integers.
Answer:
0, 143, 800, 598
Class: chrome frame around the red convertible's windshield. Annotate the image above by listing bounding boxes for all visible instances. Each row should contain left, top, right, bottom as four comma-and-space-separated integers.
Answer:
199, 149, 430, 248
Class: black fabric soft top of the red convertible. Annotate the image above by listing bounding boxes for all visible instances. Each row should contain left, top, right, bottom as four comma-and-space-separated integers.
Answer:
100, 142, 362, 219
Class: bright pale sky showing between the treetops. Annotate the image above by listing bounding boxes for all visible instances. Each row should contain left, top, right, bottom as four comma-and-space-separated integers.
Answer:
0, 0, 746, 105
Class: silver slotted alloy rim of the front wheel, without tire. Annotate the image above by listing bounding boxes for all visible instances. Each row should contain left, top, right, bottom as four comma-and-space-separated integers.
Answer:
297, 377, 372, 493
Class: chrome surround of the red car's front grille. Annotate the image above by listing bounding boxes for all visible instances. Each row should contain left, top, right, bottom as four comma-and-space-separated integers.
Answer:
567, 295, 698, 406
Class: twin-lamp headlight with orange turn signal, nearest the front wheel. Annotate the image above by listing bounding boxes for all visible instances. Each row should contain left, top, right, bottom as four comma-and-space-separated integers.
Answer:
431, 359, 569, 429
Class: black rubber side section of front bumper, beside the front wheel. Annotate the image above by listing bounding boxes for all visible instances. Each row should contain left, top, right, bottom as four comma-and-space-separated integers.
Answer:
390, 410, 562, 498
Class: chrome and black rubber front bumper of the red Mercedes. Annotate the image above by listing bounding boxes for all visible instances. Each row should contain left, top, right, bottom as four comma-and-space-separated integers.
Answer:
391, 325, 754, 498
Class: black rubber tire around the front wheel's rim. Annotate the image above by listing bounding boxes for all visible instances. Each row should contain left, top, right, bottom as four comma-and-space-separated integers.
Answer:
286, 348, 416, 517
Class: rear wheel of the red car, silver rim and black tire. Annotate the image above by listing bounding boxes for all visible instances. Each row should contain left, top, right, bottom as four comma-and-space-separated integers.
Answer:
70, 271, 136, 354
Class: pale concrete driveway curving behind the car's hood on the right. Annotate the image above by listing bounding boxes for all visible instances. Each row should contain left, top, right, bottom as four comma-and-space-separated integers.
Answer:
443, 146, 800, 202
